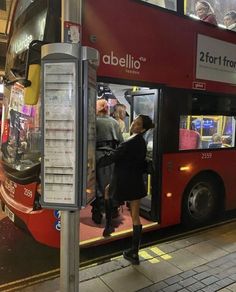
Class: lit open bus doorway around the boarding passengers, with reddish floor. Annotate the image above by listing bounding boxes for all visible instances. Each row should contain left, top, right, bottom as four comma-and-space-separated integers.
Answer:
80, 83, 158, 245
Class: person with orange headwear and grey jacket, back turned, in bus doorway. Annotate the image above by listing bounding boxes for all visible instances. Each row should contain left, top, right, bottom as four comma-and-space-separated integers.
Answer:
91, 99, 123, 224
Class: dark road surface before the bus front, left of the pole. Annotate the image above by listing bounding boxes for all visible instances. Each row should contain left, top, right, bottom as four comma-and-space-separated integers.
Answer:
0, 211, 60, 291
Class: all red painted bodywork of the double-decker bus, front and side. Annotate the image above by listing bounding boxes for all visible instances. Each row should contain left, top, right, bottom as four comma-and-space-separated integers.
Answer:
0, 0, 236, 247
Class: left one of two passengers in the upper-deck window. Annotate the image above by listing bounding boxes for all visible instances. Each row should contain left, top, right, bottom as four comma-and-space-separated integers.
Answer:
195, 1, 217, 25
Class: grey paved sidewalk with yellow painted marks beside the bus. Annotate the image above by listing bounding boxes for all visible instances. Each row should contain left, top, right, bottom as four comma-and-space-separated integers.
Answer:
20, 222, 236, 292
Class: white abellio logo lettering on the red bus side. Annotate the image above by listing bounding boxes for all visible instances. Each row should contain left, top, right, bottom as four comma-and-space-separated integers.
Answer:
102, 51, 146, 73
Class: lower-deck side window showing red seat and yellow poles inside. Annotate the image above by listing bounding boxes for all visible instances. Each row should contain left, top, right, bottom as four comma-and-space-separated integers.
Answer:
179, 115, 235, 150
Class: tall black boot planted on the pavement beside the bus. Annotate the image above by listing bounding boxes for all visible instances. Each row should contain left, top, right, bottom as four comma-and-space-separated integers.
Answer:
123, 225, 142, 265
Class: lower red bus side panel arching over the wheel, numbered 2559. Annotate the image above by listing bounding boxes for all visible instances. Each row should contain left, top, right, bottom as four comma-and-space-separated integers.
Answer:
161, 149, 236, 227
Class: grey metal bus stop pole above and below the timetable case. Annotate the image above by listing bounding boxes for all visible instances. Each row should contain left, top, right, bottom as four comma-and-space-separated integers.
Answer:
60, 0, 82, 292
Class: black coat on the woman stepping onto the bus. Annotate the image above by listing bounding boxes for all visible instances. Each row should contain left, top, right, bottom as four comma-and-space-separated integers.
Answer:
98, 134, 147, 202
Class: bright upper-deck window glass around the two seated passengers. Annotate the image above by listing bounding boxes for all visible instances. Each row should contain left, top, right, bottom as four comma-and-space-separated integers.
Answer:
185, 0, 236, 28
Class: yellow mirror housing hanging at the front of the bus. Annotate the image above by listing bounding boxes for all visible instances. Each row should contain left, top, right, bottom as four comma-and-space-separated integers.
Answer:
24, 64, 40, 105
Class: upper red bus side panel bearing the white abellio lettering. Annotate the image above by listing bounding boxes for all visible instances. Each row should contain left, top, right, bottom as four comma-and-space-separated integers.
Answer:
82, 0, 236, 93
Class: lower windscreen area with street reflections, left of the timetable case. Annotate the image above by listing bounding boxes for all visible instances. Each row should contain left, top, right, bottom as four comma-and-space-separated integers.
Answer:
1, 85, 41, 170
